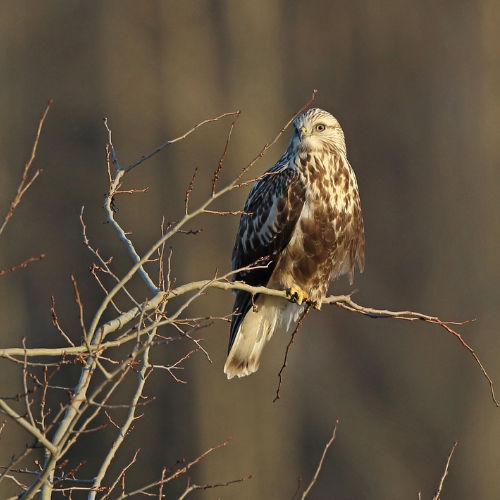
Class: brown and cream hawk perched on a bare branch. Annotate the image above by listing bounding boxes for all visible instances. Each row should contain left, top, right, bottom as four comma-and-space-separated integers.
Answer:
224, 108, 365, 379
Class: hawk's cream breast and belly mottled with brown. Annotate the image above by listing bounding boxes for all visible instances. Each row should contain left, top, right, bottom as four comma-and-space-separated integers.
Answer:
276, 153, 359, 294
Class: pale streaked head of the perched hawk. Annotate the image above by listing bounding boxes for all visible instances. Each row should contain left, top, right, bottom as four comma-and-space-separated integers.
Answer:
290, 108, 346, 154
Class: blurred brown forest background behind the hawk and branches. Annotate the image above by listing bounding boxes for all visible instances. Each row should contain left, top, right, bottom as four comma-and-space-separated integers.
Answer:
0, 0, 500, 499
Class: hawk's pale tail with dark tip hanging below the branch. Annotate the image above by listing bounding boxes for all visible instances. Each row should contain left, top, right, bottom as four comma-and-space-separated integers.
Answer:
224, 292, 303, 379
